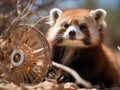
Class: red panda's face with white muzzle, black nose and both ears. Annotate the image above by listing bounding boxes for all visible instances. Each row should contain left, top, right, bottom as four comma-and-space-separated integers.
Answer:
47, 9, 106, 47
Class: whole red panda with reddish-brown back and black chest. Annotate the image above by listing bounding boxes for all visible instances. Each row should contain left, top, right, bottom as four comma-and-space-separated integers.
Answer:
46, 8, 119, 87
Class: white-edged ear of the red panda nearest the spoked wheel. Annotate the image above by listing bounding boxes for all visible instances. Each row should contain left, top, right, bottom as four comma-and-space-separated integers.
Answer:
47, 8, 62, 25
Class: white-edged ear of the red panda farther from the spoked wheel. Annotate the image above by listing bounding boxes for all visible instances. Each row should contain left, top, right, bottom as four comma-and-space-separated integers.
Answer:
90, 9, 107, 24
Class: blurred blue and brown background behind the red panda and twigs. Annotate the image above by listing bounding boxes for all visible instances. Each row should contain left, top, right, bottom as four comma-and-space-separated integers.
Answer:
0, 0, 120, 50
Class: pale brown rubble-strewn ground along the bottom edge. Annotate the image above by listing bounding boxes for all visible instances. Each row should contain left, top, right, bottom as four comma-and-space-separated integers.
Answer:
0, 79, 120, 90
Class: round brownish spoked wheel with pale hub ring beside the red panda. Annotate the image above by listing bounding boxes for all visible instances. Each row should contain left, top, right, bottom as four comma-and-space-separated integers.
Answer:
0, 25, 51, 85
